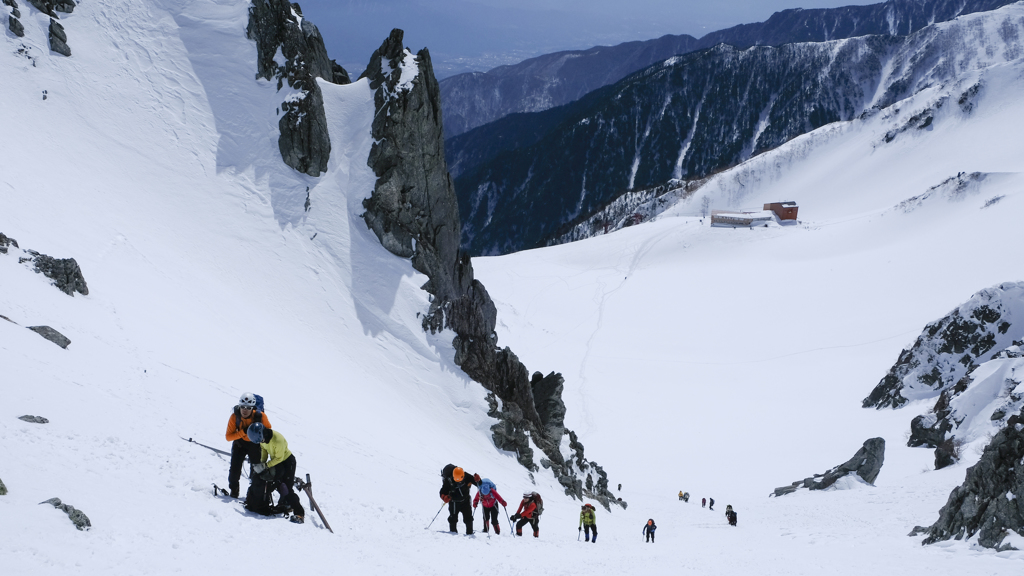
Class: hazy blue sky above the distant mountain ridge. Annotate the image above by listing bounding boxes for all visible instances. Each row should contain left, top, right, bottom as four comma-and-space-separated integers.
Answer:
298, 0, 882, 78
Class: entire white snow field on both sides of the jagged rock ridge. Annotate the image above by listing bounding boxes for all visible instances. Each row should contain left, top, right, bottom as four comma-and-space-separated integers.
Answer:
0, 0, 1024, 575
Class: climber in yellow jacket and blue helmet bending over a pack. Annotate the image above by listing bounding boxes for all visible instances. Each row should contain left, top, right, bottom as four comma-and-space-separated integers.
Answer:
246, 422, 306, 524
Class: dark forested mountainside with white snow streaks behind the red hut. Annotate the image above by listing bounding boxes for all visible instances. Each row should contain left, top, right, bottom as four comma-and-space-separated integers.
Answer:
446, 4, 1024, 254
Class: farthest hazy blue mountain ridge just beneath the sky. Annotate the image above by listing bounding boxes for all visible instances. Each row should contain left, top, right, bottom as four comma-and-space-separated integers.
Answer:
440, 0, 1013, 139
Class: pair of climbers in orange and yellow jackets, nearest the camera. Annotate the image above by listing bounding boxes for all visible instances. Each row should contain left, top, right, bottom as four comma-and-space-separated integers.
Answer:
224, 393, 305, 524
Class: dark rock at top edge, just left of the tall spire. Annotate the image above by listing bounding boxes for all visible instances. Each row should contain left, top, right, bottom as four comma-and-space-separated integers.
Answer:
246, 0, 348, 176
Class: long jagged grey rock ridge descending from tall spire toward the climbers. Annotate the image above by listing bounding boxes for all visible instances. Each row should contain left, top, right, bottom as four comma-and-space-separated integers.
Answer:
362, 30, 621, 506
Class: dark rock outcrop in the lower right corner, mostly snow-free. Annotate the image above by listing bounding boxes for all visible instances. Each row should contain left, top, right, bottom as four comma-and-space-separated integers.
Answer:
911, 414, 1024, 550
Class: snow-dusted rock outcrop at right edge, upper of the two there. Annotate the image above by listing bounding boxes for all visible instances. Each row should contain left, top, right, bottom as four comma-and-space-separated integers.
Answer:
863, 282, 1024, 405
